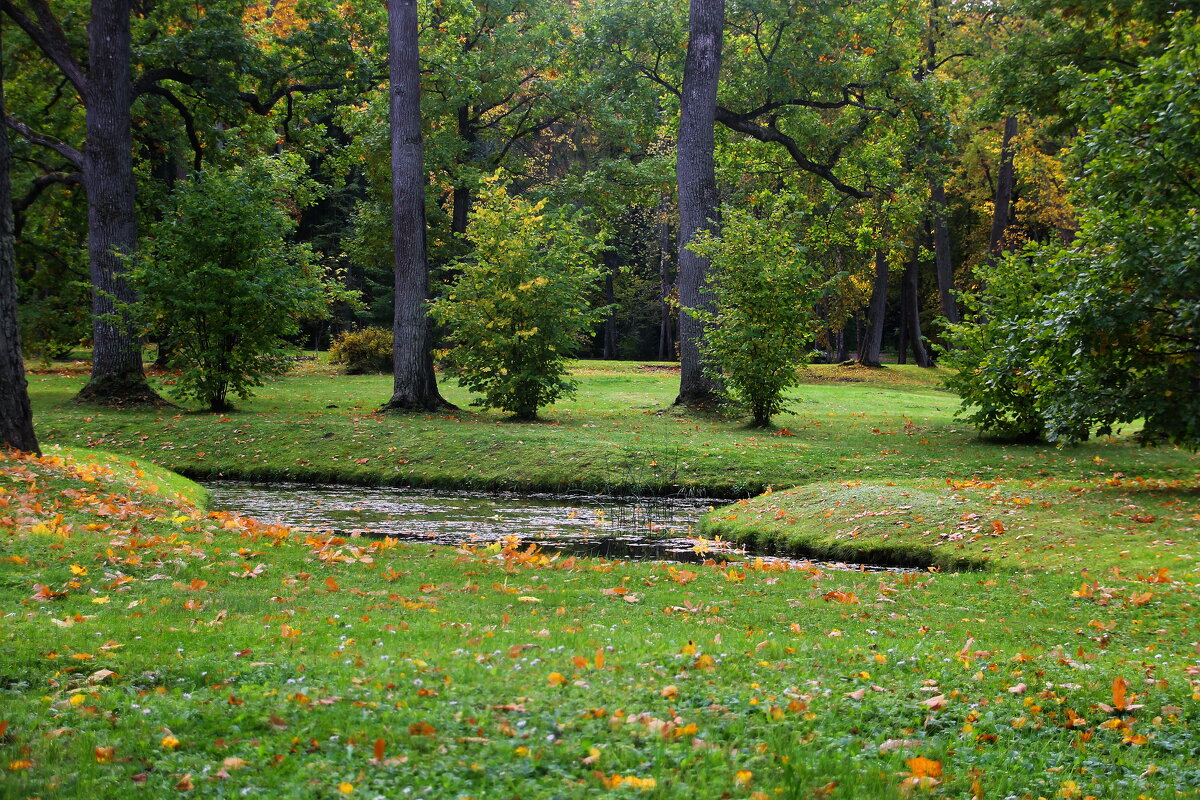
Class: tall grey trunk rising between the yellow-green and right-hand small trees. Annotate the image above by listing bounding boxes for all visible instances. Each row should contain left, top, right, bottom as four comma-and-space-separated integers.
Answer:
676, 0, 725, 405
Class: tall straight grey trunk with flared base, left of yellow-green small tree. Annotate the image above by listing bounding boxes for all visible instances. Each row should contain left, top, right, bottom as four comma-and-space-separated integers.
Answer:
383, 0, 449, 411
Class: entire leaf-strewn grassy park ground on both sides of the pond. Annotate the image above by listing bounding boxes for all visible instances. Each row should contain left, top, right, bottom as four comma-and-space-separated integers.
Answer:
0, 362, 1200, 800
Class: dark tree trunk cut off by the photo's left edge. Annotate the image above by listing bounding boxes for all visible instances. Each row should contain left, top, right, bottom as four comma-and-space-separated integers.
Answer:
0, 18, 41, 453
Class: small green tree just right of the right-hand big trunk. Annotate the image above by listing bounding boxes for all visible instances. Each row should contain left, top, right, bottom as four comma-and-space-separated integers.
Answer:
689, 207, 823, 426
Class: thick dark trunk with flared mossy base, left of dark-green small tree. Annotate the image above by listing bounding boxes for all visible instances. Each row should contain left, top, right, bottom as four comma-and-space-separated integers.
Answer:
78, 0, 161, 403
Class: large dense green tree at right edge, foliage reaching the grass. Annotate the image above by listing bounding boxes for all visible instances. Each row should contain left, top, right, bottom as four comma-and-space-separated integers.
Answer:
955, 16, 1200, 449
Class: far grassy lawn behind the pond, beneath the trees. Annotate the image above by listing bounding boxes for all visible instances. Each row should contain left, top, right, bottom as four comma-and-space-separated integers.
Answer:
21, 362, 1200, 498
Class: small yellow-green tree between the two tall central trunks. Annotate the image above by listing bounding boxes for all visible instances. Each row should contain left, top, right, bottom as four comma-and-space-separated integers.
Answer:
432, 179, 605, 420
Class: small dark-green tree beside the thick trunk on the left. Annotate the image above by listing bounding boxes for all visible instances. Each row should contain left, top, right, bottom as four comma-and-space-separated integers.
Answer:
130, 158, 338, 411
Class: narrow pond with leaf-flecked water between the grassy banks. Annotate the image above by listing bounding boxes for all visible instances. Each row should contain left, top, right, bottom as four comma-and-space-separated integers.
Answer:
204, 481, 907, 570
